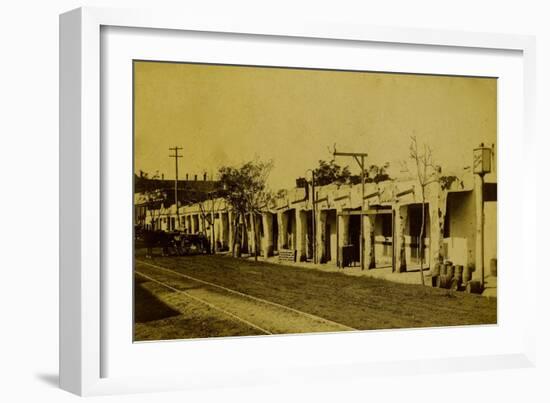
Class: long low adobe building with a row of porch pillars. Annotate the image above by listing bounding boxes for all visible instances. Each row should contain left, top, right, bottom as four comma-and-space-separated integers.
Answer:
145, 166, 497, 288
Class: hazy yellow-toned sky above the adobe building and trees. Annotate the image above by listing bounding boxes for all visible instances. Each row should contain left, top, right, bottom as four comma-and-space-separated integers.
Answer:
134, 61, 497, 190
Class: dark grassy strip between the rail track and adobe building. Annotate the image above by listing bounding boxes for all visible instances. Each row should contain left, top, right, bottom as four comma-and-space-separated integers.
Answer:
137, 252, 497, 330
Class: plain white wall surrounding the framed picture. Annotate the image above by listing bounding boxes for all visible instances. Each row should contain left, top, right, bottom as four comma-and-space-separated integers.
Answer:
0, 0, 550, 403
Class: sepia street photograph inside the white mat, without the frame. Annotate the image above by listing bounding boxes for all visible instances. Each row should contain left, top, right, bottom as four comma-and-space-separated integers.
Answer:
134, 60, 498, 342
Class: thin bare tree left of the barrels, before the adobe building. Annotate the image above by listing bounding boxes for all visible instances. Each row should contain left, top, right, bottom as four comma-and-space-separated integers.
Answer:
409, 136, 439, 285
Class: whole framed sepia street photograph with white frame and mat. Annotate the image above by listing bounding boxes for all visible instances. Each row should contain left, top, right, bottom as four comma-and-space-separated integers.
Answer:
60, 8, 536, 395
